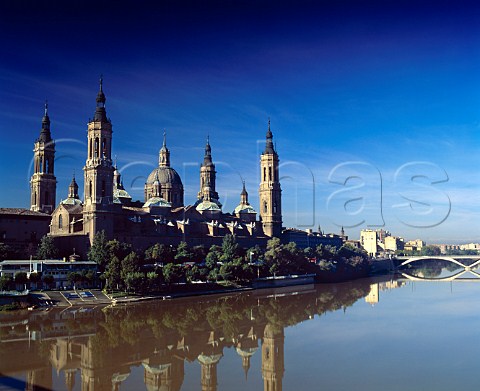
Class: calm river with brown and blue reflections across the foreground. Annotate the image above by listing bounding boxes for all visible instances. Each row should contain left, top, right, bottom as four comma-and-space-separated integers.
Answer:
0, 268, 480, 391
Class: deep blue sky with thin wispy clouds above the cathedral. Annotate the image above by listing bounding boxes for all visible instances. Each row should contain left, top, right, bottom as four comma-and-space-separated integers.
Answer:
0, 0, 480, 243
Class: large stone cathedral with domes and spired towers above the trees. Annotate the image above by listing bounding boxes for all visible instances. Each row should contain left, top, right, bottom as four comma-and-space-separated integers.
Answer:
35, 80, 282, 255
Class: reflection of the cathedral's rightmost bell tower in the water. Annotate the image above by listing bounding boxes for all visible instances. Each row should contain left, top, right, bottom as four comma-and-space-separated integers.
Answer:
262, 324, 285, 391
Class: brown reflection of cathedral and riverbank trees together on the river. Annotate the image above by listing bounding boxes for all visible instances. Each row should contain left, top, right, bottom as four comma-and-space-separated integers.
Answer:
0, 282, 376, 391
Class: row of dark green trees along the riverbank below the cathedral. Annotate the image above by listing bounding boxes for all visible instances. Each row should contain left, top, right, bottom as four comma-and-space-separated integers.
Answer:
0, 232, 371, 308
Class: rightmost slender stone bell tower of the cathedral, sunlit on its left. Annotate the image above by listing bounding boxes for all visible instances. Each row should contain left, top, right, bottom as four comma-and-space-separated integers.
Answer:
259, 119, 282, 237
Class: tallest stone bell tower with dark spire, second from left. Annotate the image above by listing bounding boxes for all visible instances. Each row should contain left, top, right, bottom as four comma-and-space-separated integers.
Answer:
83, 78, 114, 241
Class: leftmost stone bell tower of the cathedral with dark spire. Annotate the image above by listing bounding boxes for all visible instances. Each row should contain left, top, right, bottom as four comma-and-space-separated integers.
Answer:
30, 102, 57, 213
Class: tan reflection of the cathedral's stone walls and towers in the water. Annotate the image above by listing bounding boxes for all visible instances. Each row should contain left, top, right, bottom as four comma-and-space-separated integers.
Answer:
20, 325, 284, 391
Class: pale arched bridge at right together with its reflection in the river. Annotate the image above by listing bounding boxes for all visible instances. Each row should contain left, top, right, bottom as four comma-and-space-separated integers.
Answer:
397, 255, 480, 282
